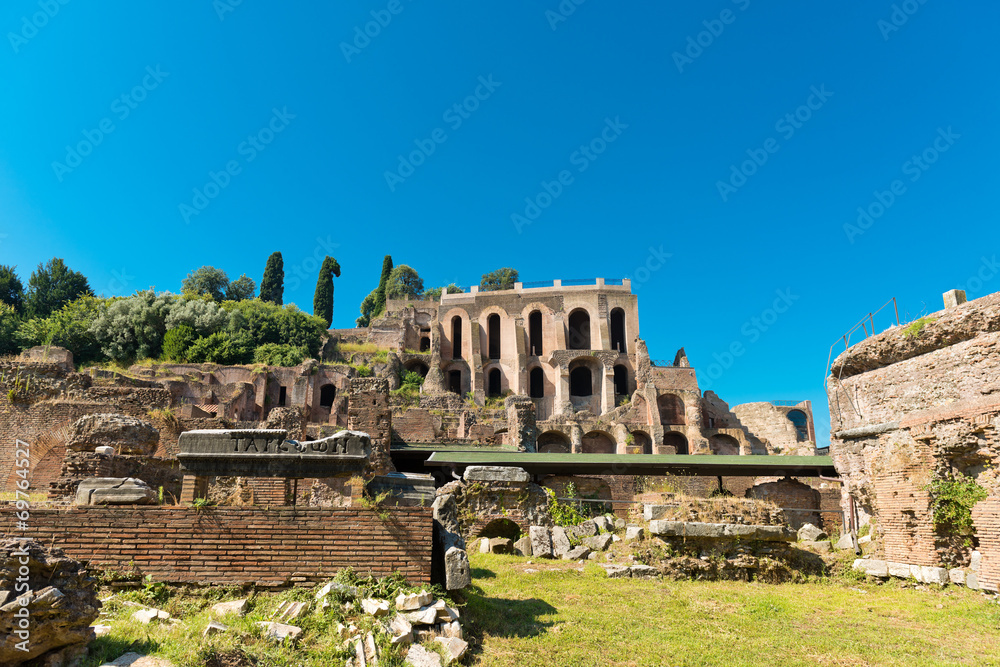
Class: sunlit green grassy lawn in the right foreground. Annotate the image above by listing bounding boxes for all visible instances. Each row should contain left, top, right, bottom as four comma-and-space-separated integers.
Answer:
462, 553, 1000, 667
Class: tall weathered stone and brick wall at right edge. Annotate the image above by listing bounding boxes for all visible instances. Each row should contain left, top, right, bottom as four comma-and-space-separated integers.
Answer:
827, 294, 1000, 587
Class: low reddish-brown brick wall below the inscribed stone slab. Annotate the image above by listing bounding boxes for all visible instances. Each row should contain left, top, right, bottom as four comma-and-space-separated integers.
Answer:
0, 506, 433, 586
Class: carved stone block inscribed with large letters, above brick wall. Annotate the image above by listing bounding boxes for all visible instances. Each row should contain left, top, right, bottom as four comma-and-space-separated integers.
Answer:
177, 429, 371, 478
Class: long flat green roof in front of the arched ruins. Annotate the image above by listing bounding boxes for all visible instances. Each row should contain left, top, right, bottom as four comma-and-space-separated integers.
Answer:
425, 450, 838, 477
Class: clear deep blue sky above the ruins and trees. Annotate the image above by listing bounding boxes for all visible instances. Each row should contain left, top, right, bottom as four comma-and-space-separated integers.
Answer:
0, 0, 1000, 441
